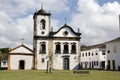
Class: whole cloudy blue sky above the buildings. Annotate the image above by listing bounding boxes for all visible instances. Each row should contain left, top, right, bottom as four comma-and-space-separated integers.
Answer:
0, 0, 120, 48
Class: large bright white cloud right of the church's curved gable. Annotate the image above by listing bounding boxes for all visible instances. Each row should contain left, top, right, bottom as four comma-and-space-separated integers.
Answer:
71, 0, 120, 45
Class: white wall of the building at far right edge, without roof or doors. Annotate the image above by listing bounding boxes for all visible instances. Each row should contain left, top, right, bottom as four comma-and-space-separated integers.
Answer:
106, 41, 120, 70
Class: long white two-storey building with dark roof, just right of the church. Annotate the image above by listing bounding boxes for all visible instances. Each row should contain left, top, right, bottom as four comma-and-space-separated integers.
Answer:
80, 44, 107, 69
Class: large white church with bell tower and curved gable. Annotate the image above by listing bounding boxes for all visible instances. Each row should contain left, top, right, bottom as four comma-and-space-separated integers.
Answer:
33, 8, 81, 70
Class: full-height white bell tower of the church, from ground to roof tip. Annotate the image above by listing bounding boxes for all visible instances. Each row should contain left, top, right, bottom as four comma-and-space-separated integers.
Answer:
33, 6, 51, 69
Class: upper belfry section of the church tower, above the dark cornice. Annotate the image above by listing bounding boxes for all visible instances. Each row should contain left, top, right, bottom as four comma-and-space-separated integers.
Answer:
33, 6, 51, 37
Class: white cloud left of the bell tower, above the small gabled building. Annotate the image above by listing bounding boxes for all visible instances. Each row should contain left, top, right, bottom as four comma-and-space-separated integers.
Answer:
0, 12, 33, 47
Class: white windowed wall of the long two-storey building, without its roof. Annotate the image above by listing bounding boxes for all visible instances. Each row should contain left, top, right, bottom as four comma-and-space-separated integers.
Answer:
80, 48, 107, 69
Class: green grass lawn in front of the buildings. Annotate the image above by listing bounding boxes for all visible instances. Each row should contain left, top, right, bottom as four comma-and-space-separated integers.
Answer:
0, 70, 120, 80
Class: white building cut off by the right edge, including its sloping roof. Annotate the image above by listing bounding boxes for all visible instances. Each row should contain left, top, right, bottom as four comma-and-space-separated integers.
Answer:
106, 37, 120, 70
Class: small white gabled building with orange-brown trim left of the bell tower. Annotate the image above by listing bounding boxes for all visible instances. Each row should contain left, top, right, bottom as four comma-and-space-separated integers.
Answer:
8, 44, 34, 70
